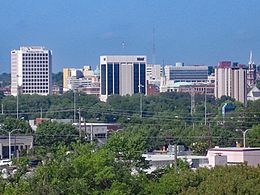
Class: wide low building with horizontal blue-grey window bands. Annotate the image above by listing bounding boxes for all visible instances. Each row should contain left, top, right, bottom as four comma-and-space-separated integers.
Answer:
165, 62, 208, 83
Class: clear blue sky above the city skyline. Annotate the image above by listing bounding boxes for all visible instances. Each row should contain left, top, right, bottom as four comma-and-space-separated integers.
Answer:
0, 0, 260, 73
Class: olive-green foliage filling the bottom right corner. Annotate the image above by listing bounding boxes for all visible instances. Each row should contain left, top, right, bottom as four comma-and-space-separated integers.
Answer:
145, 166, 260, 194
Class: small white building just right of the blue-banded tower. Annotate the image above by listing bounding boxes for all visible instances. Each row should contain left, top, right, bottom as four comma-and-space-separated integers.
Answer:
146, 64, 162, 82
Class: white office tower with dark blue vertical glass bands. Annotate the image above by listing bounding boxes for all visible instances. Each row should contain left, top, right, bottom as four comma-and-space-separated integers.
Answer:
100, 56, 146, 101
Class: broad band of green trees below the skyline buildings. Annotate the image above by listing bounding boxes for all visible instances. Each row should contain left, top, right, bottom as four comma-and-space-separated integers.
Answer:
0, 92, 260, 149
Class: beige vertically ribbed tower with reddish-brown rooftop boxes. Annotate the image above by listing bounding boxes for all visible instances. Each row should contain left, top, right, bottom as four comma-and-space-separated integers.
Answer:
215, 61, 247, 104
